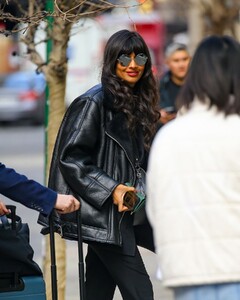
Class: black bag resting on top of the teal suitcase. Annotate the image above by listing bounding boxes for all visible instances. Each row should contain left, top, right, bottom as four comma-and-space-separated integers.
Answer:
0, 205, 42, 276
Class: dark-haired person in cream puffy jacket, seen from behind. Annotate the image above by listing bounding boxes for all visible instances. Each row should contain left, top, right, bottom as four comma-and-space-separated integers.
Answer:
147, 36, 240, 300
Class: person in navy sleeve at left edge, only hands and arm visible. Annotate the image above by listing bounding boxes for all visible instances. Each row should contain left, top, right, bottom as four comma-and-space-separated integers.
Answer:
0, 163, 80, 215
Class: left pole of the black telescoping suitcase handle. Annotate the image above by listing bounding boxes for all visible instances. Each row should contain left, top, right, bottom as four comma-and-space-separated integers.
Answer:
49, 212, 58, 300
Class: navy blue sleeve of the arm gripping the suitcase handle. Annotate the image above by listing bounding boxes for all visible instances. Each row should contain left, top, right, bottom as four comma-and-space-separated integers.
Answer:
0, 163, 57, 215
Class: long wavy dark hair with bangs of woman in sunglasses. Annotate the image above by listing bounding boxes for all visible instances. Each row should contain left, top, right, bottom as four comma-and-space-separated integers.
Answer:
101, 30, 159, 150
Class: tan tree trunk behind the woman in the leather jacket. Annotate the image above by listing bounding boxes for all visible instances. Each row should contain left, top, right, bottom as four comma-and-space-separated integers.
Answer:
44, 19, 72, 300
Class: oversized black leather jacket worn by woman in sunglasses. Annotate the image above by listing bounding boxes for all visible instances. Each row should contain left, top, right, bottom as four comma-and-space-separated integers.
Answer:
40, 85, 146, 245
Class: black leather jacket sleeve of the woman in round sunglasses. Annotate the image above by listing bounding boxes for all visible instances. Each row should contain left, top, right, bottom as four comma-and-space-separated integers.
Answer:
59, 98, 119, 209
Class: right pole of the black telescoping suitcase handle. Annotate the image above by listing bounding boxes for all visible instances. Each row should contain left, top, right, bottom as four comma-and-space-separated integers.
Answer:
77, 206, 86, 300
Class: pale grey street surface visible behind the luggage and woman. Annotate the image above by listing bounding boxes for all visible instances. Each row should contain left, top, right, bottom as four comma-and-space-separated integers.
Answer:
0, 125, 173, 300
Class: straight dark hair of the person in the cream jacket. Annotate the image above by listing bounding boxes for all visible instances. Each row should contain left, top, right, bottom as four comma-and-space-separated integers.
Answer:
177, 35, 240, 115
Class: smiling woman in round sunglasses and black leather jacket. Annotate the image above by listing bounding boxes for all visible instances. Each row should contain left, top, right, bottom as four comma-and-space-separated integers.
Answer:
43, 30, 159, 300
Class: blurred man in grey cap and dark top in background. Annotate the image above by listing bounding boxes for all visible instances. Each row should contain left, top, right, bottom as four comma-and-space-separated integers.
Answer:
160, 42, 190, 126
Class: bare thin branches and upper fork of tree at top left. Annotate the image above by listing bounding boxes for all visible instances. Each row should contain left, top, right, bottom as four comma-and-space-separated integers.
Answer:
0, 0, 137, 76
